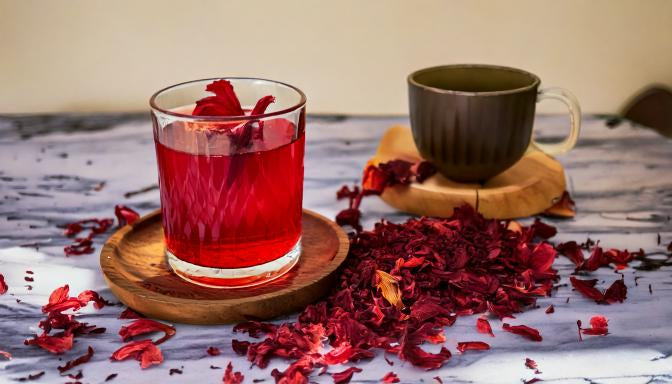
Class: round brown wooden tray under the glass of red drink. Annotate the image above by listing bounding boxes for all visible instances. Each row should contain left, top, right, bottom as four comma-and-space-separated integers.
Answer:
100, 210, 350, 324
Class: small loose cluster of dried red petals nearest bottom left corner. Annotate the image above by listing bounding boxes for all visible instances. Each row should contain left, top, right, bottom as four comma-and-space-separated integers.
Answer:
24, 285, 111, 353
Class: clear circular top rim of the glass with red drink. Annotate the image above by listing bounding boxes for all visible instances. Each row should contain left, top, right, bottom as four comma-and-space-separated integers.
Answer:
149, 76, 306, 121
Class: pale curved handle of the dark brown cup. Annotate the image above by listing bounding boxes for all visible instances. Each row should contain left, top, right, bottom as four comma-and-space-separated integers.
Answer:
532, 87, 581, 156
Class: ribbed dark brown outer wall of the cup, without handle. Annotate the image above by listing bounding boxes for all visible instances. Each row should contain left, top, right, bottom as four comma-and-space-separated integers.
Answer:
408, 82, 538, 181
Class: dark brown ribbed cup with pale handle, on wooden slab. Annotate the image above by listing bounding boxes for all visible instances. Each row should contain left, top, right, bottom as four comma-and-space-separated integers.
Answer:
408, 64, 581, 182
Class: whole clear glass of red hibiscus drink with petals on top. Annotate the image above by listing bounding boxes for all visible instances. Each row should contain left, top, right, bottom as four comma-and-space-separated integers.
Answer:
150, 78, 306, 288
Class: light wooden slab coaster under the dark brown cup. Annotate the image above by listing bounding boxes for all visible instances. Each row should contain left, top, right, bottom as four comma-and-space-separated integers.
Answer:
370, 126, 565, 219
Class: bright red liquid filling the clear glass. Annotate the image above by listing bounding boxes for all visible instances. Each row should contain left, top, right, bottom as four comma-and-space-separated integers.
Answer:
156, 119, 305, 268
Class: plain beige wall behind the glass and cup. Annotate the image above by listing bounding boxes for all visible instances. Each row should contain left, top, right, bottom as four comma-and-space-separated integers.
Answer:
0, 0, 672, 114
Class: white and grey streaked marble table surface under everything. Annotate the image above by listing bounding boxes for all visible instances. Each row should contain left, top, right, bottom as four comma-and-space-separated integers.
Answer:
0, 114, 672, 384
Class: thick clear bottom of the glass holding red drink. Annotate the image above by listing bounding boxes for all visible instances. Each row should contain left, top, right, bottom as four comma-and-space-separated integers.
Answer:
166, 238, 301, 288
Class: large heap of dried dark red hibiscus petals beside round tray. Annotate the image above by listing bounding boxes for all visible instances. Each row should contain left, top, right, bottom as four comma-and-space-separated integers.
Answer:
233, 206, 558, 382
